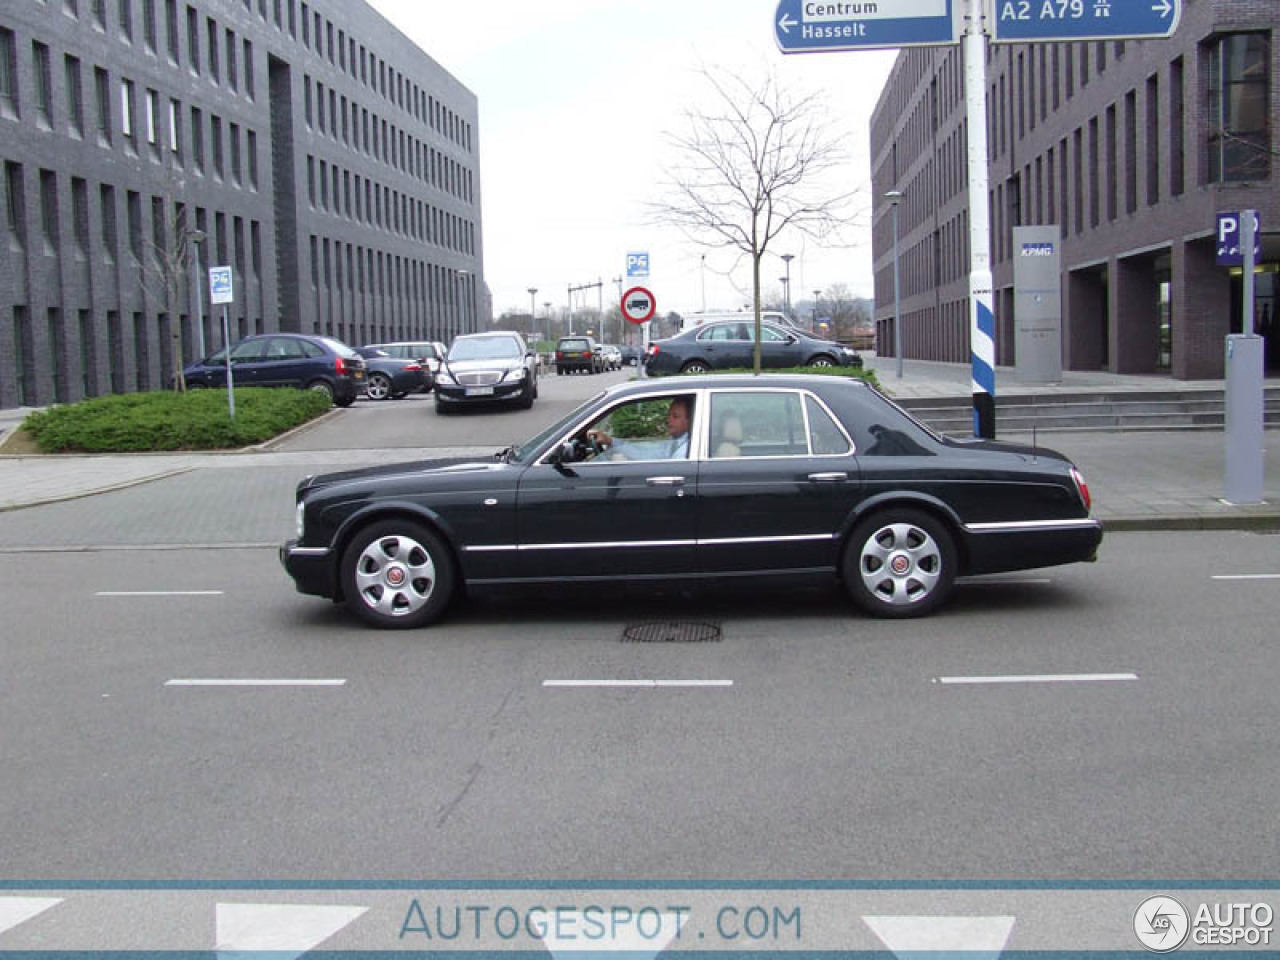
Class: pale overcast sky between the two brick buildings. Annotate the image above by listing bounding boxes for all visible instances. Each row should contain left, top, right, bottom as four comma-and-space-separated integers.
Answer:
371, 0, 895, 323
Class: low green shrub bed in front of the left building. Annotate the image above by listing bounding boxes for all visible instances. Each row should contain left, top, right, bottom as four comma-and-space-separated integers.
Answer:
22, 387, 333, 453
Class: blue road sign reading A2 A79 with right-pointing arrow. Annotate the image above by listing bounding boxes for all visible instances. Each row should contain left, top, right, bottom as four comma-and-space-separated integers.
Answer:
989, 0, 1183, 44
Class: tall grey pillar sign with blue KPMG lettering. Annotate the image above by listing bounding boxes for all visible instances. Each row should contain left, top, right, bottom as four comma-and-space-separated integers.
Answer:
1014, 227, 1062, 383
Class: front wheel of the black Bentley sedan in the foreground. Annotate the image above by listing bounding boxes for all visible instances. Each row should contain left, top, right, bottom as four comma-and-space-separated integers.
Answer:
339, 517, 456, 630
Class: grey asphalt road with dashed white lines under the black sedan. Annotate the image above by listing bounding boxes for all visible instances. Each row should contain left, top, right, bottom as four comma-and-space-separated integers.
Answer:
0, 522, 1280, 882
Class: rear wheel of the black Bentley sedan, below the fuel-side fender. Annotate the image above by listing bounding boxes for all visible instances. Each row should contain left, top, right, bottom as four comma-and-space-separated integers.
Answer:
842, 507, 957, 620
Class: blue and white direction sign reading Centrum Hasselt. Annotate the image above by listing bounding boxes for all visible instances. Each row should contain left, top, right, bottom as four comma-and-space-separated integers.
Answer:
773, 0, 960, 54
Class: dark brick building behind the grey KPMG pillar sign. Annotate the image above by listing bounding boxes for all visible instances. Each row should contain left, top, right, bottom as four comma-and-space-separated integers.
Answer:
870, 0, 1280, 379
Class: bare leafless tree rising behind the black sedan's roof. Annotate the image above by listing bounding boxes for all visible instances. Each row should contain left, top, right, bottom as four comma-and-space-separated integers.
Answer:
650, 69, 858, 372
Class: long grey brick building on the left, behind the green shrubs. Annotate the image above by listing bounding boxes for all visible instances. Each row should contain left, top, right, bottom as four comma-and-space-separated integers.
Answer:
0, 0, 488, 407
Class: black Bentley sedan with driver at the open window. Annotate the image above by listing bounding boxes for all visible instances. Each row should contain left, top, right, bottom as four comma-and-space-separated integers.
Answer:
280, 375, 1102, 627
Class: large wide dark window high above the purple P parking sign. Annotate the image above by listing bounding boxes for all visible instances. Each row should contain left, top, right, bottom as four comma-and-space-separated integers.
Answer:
1206, 33, 1271, 183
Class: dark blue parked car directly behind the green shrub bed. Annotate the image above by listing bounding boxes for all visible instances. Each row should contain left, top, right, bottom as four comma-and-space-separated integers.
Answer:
182, 333, 365, 407
